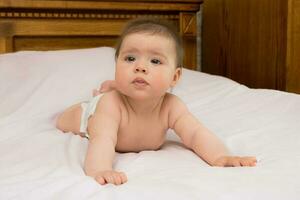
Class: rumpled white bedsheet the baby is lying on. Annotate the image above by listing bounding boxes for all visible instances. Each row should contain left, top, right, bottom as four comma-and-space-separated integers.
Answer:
0, 48, 300, 200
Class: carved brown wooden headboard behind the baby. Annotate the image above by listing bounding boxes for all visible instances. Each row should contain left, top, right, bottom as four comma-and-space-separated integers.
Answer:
0, 0, 202, 69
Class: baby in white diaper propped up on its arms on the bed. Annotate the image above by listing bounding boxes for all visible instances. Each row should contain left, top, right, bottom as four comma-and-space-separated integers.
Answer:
57, 19, 256, 185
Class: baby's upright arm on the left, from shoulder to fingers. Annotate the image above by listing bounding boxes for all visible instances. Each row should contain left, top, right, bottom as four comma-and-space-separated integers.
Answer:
84, 95, 127, 185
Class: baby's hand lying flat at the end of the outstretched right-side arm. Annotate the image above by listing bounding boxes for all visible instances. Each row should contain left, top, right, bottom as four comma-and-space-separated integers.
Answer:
213, 156, 257, 167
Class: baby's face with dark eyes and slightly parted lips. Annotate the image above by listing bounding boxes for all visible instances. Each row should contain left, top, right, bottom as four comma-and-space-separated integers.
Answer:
115, 33, 180, 99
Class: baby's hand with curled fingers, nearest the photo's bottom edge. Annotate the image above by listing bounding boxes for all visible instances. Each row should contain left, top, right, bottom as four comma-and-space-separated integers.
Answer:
95, 170, 127, 185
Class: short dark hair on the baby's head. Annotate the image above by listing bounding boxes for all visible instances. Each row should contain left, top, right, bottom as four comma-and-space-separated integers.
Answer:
115, 18, 183, 68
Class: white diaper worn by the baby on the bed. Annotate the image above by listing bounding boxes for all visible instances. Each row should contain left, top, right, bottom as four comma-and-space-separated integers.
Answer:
80, 94, 102, 138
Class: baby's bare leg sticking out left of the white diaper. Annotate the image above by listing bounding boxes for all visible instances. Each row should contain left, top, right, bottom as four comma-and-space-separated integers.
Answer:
56, 103, 82, 134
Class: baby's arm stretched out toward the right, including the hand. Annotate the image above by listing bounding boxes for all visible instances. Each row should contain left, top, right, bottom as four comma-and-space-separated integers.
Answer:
169, 96, 256, 167
